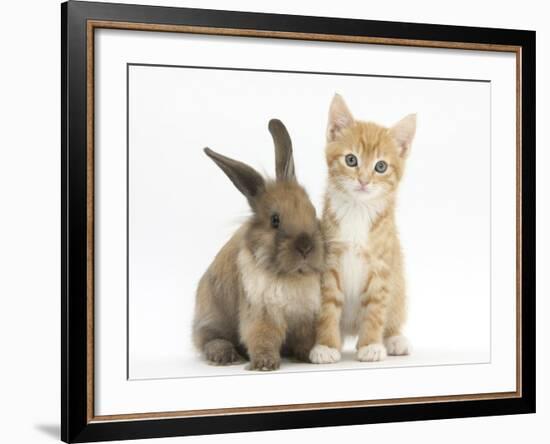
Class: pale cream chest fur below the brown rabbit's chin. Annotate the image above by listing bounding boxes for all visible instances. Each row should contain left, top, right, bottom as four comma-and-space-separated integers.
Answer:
238, 250, 321, 320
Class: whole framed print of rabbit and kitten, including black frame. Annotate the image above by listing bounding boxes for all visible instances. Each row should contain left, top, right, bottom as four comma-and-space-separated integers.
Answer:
61, 1, 535, 442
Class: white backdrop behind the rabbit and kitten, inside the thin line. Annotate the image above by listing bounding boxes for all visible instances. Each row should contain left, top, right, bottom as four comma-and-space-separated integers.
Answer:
128, 64, 492, 378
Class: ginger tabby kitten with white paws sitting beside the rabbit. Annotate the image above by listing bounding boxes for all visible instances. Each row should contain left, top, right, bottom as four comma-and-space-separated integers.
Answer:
310, 94, 416, 364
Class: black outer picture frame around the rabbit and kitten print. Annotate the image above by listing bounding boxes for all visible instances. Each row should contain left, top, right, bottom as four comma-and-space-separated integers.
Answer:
61, 1, 536, 442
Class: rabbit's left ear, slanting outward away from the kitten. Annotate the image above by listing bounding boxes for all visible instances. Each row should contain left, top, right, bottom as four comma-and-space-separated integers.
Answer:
204, 148, 265, 207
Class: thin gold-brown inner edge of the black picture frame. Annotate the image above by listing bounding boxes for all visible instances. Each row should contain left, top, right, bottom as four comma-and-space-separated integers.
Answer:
86, 20, 522, 423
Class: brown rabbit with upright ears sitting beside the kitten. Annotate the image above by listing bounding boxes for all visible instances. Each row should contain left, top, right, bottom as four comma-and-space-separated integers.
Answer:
193, 119, 324, 370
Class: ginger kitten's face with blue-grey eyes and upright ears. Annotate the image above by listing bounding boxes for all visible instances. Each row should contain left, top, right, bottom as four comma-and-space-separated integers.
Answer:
326, 95, 416, 201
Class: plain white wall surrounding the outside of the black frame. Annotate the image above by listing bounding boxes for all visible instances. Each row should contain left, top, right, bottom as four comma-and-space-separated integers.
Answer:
0, 0, 550, 444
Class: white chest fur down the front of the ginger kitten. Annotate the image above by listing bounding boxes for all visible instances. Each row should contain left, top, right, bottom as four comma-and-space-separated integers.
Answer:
331, 191, 386, 334
